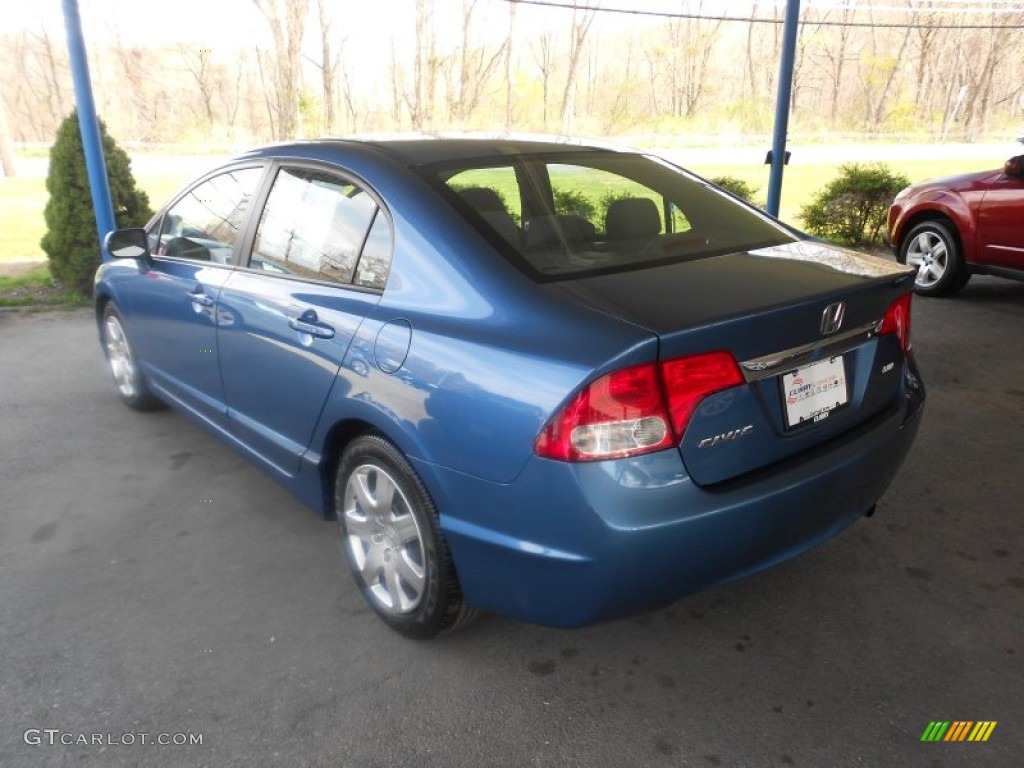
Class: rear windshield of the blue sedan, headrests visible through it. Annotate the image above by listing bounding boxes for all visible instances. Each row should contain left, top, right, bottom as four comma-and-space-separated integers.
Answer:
424, 152, 796, 280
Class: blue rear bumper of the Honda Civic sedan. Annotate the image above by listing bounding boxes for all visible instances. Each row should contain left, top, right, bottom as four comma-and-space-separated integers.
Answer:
425, 376, 924, 627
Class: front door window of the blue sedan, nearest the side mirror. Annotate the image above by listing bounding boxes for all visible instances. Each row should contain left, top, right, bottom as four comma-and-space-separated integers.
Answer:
151, 168, 263, 264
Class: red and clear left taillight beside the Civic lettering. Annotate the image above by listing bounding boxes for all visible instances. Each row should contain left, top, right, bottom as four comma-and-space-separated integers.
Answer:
534, 352, 743, 462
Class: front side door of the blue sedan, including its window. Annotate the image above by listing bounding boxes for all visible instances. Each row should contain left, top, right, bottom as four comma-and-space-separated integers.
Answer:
132, 165, 263, 424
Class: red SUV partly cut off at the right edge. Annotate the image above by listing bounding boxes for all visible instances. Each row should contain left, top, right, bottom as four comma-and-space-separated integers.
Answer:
889, 155, 1024, 296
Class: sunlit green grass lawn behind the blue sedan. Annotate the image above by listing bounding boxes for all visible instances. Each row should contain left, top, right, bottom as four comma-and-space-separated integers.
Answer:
0, 148, 1006, 262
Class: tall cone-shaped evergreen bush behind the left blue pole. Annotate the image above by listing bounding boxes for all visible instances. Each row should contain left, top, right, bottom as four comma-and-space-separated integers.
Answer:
40, 112, 153, 296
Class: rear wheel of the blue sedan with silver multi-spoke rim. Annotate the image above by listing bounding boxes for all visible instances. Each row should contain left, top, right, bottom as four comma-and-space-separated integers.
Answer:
334, 435, 476, 639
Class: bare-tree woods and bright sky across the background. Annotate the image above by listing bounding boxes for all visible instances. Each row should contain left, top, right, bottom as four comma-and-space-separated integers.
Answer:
0, 0, 1024, 144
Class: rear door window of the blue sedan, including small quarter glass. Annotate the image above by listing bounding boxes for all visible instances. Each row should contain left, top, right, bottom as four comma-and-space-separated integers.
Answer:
249, 168, 391, 288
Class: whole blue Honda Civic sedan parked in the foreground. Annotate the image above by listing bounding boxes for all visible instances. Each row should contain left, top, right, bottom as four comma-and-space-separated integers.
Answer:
95, 139, 925, 638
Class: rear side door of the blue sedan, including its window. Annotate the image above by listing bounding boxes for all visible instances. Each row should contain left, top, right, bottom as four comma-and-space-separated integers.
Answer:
217, 165, 391, 474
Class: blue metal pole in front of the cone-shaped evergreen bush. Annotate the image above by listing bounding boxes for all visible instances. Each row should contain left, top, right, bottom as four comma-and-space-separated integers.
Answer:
63, 0, 115, 261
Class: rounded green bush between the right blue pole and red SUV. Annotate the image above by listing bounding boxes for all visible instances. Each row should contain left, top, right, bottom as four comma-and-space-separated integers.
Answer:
800, 163, 910, 246
